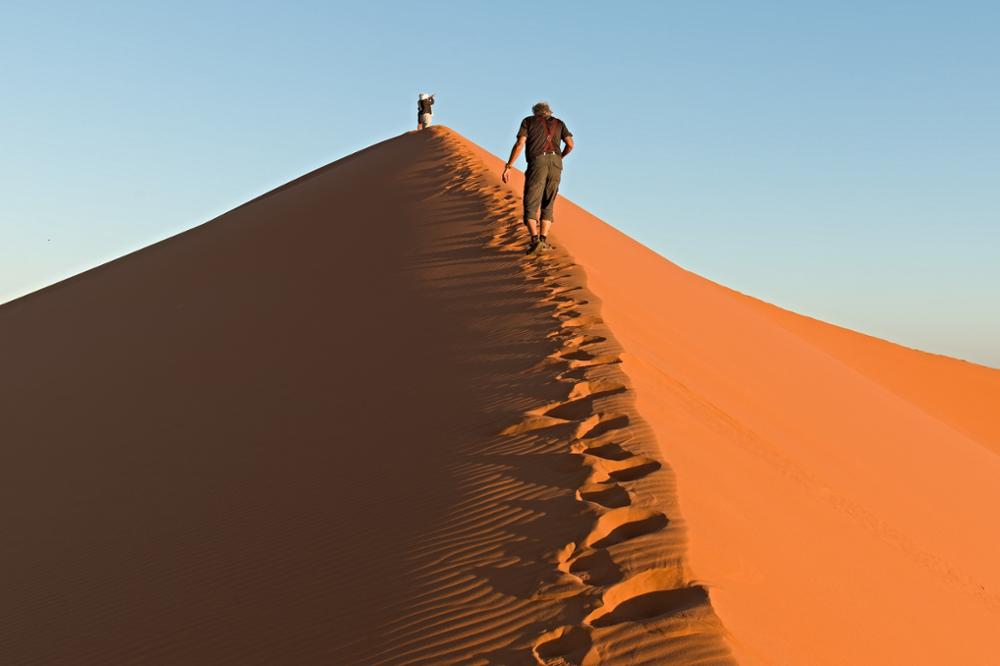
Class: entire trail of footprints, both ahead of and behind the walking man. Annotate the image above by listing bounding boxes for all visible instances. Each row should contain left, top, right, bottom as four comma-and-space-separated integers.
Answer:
434, 132, 708, 666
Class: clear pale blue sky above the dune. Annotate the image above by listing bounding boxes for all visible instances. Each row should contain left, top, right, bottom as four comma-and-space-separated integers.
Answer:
0, 0, 1000, 367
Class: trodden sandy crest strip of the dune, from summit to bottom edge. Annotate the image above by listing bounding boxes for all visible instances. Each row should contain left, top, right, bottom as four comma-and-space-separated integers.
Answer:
430, 127, 731, 665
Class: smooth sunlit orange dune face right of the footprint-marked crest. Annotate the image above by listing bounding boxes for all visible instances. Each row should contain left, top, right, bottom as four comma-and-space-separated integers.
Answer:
458, 132, 1000, 664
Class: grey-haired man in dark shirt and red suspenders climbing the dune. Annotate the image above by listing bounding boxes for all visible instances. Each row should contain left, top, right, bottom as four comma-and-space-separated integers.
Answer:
502, 102, 573, 254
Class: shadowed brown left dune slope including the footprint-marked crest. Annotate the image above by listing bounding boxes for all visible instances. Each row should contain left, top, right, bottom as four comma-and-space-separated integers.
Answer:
0, 128, 732, 666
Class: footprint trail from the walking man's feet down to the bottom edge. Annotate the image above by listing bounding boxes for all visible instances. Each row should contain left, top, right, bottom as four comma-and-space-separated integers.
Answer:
509, 274, 695, 665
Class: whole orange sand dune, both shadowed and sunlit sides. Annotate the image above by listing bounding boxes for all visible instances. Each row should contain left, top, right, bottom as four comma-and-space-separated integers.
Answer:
0, 127, 1000, 665
